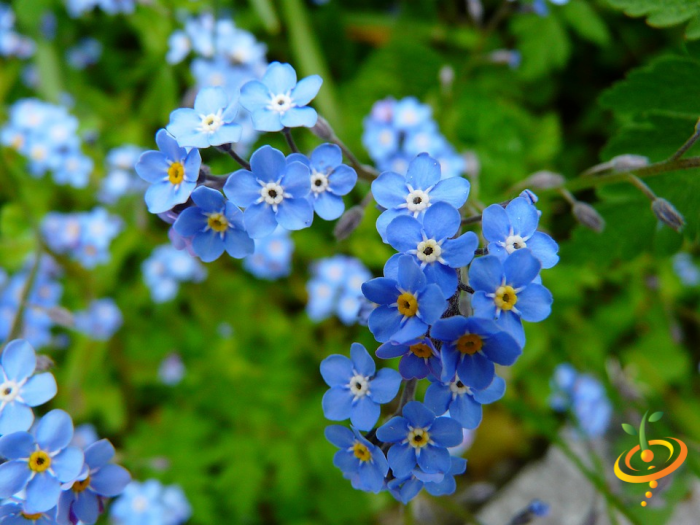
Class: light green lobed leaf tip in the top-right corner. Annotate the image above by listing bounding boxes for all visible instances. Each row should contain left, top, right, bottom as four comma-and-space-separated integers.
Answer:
608, 0, 700, 39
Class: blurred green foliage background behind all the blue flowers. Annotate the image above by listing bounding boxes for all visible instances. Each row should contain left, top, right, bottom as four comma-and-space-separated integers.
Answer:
0, 0, 700, 525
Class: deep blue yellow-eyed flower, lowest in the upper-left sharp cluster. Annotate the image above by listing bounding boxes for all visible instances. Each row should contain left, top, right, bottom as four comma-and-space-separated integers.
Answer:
173, 186, 254, 262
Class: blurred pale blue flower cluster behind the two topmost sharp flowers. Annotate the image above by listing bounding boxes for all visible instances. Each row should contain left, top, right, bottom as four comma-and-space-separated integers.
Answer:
166, 13, 267, 154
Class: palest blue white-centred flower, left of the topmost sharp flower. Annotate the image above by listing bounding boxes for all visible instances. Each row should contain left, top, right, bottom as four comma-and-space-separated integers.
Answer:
166, 87, 242, 148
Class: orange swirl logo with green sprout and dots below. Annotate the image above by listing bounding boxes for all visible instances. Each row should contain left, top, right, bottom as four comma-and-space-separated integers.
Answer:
615, 411, 688, 507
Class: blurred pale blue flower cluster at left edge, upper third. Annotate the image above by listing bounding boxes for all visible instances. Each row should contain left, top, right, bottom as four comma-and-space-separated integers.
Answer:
0, 98, 93, 188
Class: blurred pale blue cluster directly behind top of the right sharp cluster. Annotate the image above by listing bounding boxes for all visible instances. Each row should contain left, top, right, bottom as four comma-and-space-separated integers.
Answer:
362, 97, 468, 179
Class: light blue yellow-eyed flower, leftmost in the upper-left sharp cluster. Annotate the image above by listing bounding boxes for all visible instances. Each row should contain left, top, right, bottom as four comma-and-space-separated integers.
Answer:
134, 129, 202, 213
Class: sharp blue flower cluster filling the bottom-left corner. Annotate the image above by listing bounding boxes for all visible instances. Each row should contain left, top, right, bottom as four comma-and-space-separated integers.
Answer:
0, 339, 131, 525
